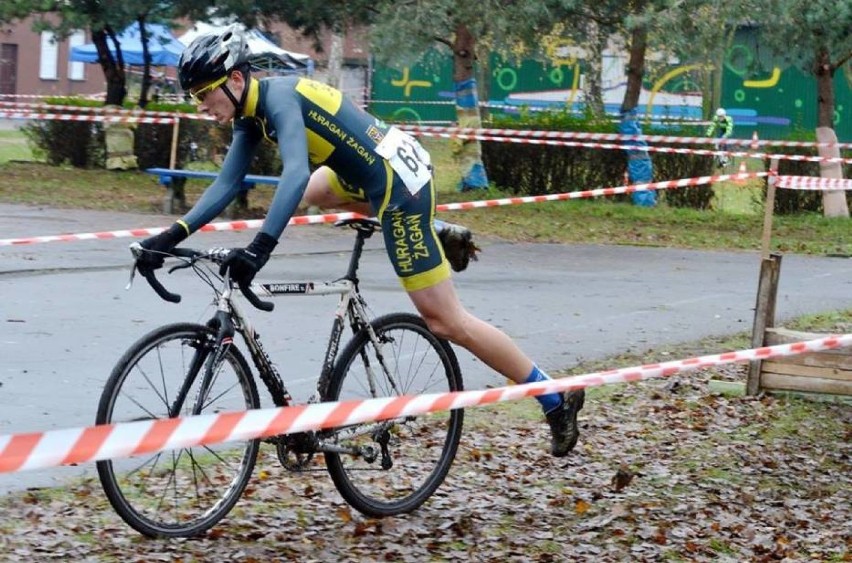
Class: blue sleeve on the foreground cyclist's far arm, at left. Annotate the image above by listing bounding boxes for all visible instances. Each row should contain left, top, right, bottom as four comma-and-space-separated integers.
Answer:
183, 124, 260, 232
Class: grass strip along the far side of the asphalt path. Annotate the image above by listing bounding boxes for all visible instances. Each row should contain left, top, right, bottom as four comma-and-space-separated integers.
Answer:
0, 131, 852, 256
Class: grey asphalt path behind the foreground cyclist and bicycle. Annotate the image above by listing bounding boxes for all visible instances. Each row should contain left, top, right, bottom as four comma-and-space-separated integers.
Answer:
0, 205, 852, 493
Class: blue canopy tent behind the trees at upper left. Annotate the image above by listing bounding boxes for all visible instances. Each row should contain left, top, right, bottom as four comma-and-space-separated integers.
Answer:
68, 22, 184, 66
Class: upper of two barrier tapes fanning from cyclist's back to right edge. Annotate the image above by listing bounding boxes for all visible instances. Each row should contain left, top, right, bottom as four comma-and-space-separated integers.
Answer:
397, 124, 852, 148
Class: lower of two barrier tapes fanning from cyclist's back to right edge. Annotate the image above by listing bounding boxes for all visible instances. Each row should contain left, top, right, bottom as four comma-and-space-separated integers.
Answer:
404, 131, 852, 164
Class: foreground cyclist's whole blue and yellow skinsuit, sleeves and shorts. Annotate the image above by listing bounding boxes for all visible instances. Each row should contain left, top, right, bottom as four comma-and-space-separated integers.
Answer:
183, 76, 450, 290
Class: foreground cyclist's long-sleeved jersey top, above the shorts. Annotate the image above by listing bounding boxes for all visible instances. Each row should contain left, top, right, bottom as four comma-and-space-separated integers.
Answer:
184, 76, 388, 238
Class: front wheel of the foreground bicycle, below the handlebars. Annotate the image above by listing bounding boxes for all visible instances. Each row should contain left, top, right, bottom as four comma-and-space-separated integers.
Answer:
96, 323, 260, 537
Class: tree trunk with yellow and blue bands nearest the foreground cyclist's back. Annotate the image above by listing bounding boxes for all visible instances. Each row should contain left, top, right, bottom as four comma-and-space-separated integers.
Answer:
453, 24, 488, 191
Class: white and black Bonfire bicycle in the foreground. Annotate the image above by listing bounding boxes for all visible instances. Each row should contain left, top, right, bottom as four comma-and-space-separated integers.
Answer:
96, 219, 463, 537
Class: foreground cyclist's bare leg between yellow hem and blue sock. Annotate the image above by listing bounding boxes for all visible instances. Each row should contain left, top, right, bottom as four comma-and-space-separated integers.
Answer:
408, 279, 533, 383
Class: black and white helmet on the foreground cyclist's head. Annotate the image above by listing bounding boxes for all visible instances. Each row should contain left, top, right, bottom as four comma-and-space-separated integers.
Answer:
178, 25, 250, 91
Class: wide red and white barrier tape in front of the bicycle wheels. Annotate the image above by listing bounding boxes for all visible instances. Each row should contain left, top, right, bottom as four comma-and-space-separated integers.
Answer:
0, 334, 852, 473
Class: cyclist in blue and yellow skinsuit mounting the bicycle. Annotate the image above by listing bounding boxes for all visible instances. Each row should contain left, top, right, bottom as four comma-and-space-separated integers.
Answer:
137, 27, 584, 457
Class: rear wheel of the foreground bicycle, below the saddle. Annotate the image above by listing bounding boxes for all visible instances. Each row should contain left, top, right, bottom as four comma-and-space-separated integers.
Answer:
325, 313, 464, 517
